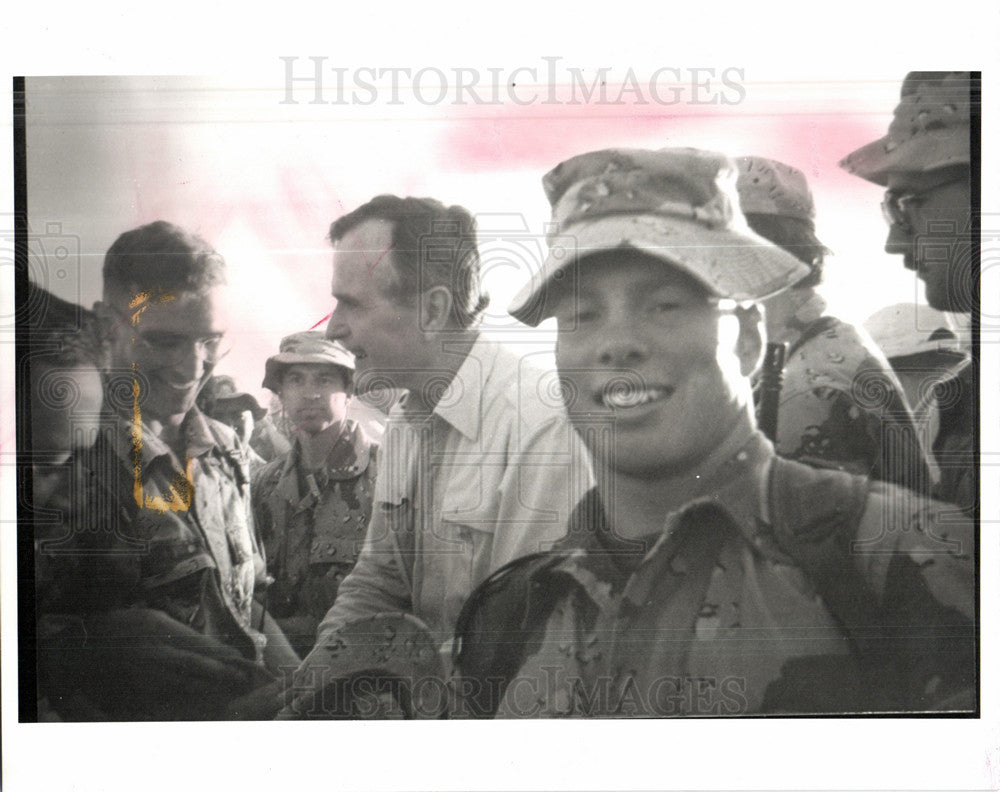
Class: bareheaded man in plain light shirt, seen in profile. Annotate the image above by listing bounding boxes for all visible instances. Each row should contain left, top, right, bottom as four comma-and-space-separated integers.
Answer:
286, 195, 589, 716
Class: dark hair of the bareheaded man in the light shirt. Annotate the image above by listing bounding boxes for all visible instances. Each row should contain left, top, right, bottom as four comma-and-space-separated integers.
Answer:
328, 195, 490, 328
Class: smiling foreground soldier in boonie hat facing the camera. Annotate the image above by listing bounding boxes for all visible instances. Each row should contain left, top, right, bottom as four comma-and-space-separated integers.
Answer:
455, 149, 975, 717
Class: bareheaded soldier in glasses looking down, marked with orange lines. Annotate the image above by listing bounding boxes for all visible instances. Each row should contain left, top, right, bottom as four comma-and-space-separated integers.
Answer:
39, 222, 297, 720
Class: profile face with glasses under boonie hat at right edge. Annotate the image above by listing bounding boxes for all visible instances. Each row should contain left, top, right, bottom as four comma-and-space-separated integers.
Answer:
883, 172, 972, 312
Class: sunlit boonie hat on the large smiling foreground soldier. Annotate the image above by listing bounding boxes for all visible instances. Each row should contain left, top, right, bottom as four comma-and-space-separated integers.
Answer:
508, 148, 809, 326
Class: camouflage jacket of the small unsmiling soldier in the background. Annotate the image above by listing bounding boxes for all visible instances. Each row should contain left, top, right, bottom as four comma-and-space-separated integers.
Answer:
252, 421, 378, 651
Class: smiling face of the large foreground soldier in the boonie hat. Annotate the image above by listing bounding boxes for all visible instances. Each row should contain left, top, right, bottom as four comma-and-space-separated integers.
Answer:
556, 250, 759, 476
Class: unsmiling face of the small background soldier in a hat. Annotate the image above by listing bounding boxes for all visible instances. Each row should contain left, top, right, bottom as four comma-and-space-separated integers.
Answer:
280, 363, 347, 435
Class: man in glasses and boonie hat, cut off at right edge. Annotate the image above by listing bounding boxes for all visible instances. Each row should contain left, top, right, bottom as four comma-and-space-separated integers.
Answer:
840, 72, 979, 516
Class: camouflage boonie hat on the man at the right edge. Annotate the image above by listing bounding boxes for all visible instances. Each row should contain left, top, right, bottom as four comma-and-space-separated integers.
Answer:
840, 72, 972, 187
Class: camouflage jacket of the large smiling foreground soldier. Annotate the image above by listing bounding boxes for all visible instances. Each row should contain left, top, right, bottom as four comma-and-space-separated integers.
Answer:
455, 435, 975, 718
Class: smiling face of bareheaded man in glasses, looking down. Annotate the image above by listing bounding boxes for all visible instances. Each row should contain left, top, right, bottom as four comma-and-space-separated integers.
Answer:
109, 286, 226, 423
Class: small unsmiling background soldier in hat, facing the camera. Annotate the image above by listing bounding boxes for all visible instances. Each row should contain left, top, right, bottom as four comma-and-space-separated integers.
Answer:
252, 331, 378, 656
